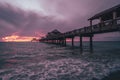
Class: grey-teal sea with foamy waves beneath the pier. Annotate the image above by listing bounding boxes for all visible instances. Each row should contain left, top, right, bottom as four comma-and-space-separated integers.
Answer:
0, 42, 120, 80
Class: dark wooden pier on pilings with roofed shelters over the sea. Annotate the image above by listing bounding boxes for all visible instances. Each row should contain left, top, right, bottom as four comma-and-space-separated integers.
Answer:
40, 5, 120, 52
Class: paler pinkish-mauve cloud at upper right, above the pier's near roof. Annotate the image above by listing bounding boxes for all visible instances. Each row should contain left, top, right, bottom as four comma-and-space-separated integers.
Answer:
40, 0, 120, 27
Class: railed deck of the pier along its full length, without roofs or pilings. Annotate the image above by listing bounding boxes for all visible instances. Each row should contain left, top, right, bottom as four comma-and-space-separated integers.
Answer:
42, 18, 120, 40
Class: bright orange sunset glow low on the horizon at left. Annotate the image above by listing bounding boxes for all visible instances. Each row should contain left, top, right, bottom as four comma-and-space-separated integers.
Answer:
2, 35, 39, 42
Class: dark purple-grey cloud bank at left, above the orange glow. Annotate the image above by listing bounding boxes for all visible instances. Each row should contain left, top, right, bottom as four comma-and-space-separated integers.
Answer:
0, 4, 68, 40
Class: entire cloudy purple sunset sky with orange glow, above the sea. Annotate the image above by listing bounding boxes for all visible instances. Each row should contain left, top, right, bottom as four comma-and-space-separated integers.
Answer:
0, 0, 120, 41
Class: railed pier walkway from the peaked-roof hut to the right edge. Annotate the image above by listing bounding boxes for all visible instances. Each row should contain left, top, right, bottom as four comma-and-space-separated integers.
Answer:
64, 18, 120, 37
